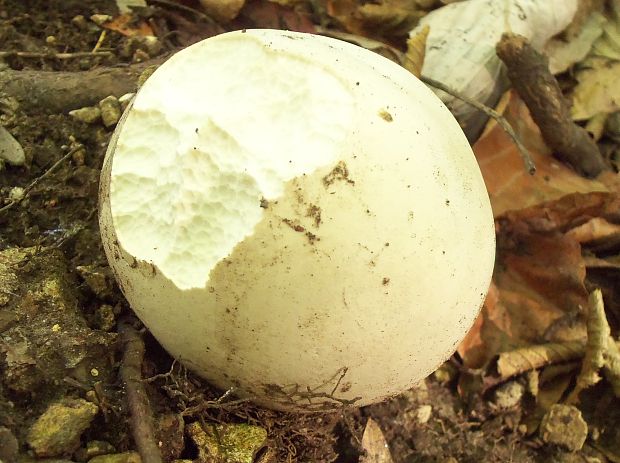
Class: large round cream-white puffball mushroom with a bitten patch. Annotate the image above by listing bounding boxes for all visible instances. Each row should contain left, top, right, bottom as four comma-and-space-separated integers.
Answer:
100, 30, 495, 411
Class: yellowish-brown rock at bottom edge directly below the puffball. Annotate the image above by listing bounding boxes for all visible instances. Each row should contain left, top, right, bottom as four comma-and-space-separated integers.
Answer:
186, 422, 267, 463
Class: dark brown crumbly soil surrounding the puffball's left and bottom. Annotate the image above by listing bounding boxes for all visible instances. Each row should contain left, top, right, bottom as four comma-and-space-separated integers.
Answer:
0, 0, 620, 463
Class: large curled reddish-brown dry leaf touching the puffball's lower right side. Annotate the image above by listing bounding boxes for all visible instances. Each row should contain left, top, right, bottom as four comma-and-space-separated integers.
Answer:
458, 193, 620, 368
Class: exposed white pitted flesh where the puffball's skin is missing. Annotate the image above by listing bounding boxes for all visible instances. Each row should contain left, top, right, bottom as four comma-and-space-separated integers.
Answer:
110, 34, 354, 289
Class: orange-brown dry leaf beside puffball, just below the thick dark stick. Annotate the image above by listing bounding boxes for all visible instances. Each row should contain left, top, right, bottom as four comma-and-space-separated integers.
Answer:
474, 92, 608, 217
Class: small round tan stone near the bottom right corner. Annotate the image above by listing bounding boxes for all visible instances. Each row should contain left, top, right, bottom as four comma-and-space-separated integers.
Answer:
540, 404, 588, 452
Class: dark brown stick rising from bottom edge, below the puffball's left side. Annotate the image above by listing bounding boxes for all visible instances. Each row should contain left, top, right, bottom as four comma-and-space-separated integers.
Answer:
118, 318, 162, 463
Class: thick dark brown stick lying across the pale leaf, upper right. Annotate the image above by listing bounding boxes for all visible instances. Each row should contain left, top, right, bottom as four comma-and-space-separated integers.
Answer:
496, 34, 608, 177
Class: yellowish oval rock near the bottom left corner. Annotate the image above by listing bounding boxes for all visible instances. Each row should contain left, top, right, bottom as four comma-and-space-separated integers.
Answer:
26, 399, 99, 457
